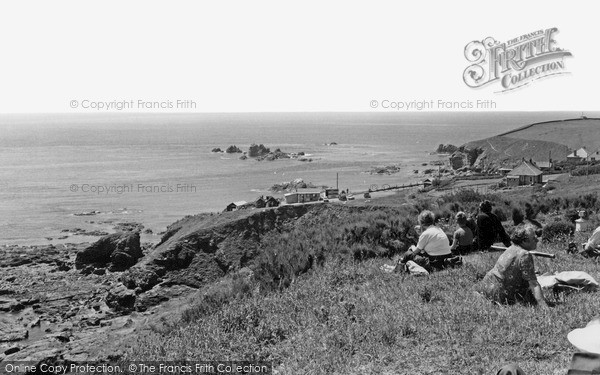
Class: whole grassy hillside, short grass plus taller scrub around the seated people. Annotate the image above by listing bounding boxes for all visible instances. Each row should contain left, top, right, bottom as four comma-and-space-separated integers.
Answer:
123, 178, 600, 375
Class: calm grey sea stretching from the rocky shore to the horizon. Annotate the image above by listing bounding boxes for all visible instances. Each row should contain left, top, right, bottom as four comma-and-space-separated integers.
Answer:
0, 113, 576, 246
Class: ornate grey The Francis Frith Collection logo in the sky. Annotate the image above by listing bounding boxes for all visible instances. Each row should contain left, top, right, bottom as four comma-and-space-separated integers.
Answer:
463, 27, 571, 92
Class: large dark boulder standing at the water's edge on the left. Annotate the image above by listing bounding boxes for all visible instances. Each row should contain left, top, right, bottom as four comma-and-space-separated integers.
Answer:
75, 232, 144, 271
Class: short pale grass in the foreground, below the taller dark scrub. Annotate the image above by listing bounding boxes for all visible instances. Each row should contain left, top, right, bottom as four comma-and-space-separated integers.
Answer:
131, 239, 600, 375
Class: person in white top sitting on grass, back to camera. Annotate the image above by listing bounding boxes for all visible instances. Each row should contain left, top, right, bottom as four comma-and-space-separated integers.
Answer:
399, 210, 452, 271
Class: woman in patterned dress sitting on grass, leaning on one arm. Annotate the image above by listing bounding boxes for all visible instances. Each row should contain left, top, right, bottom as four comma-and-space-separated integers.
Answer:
477, 225, 547, 308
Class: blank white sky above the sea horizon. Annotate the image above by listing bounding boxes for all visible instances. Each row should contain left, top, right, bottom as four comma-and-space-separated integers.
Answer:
0, 0, 600, 114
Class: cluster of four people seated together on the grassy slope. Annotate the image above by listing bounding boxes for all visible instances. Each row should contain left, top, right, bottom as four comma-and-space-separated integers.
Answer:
399, 201, 548, 306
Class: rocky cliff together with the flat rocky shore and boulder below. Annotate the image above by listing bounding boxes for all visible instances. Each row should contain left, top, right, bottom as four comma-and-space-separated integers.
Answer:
0, 205, 320, 363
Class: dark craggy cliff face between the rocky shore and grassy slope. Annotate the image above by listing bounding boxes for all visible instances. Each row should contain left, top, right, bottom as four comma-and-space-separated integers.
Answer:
111, 204, 322, 310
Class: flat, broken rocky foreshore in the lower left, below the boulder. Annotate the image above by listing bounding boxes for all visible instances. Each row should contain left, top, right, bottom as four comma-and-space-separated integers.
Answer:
0, 245, 142, 364
